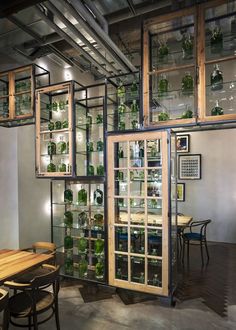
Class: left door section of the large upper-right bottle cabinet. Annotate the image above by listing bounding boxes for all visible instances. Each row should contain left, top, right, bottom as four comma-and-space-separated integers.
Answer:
143, 9, 197, 126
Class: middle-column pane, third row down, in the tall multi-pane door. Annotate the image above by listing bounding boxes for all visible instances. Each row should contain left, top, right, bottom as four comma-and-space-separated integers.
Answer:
130, 198, 145, 225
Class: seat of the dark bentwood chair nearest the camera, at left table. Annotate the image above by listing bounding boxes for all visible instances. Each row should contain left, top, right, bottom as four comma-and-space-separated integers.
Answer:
9, 290, 54, 318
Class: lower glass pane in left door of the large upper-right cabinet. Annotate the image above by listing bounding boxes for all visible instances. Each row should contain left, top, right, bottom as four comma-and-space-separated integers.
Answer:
150, 68, 195, 122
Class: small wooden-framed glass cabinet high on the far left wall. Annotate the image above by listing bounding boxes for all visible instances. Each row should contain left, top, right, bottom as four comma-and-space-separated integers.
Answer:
0, 64, 50, 127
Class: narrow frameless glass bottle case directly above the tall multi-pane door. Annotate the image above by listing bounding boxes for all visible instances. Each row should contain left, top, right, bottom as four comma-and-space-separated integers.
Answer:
106, 72, 143, 132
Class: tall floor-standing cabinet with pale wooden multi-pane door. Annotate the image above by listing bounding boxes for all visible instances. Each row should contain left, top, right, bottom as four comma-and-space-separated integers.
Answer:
107, 130, 176, 297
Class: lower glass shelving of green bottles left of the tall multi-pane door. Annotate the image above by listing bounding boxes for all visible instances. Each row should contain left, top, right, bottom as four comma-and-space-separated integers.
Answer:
51, 180, 106, 282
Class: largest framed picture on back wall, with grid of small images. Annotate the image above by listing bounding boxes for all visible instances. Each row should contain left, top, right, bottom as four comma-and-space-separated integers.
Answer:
178, 154, 201, 180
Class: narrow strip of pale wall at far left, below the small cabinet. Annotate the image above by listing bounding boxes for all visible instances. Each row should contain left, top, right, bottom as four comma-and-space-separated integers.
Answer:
0, 127, 19, 249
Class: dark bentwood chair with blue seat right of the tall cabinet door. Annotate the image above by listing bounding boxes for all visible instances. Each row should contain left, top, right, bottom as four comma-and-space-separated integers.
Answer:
182, 219, 211, 265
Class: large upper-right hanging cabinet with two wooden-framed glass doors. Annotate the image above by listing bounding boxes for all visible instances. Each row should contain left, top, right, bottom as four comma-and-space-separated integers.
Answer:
143, 0, 236, 127
